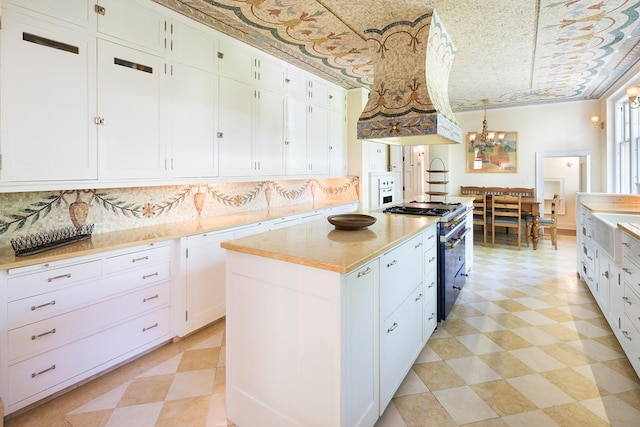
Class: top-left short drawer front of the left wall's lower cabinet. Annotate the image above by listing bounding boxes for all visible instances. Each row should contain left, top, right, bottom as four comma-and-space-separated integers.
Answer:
7, 260, 102, 300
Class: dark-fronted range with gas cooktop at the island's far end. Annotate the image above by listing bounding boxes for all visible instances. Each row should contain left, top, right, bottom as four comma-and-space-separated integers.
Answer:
383, 201, 473, 320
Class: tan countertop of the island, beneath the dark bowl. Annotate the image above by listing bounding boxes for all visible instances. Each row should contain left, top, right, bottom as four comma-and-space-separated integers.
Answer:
220, 212, 438, 274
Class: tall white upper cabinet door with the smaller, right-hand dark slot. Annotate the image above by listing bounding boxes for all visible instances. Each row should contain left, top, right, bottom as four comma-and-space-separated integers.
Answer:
98, 40, 166, 179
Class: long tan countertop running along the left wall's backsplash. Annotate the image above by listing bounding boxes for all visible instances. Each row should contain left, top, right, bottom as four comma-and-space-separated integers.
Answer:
0, 201, 356, 270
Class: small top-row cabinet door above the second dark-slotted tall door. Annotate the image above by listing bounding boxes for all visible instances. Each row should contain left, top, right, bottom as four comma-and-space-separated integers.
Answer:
97, 0, 167, 52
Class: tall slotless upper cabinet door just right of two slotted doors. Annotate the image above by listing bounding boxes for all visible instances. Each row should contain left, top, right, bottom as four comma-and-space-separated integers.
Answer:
168, 63, 218, 178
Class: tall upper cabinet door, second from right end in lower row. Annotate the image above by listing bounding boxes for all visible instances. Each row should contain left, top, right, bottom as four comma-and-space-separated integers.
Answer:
307, 105, 329, 175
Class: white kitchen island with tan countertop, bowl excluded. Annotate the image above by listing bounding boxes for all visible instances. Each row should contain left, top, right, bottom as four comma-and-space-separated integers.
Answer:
221, 213, 437, 427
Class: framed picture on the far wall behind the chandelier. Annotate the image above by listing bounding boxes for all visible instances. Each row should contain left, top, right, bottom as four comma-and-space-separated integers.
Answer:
467, 132, 518, 173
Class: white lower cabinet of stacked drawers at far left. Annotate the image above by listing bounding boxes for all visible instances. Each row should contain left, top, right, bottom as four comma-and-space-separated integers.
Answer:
0, 242, 173, 414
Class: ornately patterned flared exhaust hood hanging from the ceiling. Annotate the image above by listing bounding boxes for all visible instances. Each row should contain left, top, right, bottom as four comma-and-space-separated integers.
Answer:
358, 10, 462, 145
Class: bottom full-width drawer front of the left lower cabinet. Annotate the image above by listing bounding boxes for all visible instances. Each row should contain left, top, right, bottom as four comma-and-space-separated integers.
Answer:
6, 307, 171, 406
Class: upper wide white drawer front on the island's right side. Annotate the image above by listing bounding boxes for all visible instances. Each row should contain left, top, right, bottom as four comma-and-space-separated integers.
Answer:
380, 235, 423, 319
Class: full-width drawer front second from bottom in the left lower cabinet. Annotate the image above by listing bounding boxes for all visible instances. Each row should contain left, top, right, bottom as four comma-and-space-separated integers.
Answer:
8, 282, 170, 361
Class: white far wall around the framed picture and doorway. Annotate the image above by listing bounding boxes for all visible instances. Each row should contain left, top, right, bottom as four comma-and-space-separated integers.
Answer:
448, 101, 606, 194
